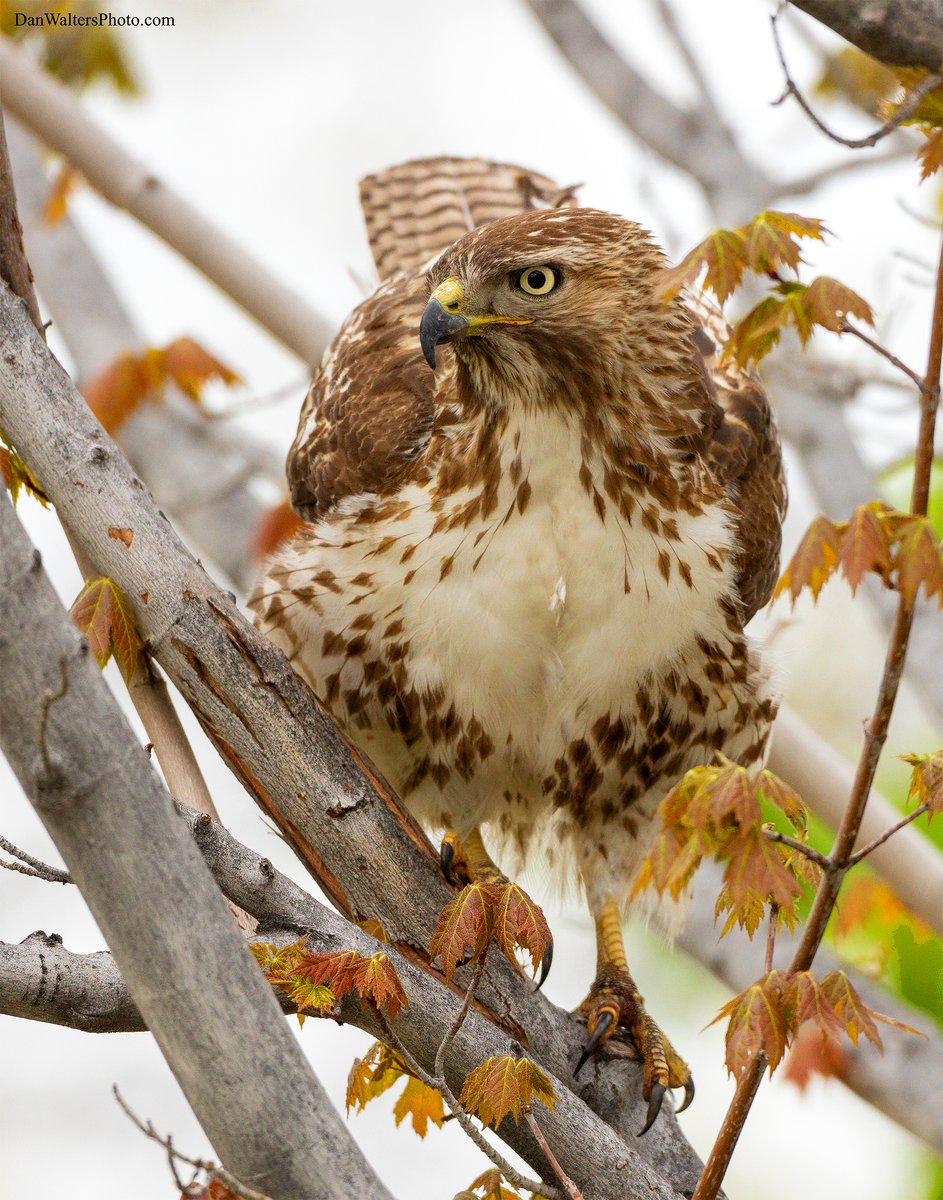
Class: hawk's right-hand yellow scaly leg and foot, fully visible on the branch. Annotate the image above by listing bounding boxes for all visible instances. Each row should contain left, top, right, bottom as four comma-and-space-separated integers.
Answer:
573, 896, 695, 1138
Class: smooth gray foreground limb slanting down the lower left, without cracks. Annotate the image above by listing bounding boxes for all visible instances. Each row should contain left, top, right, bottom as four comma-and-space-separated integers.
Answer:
0, 487, 389, 1200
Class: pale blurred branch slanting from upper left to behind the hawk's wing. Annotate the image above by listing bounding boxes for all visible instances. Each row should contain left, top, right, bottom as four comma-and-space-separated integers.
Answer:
0, 38, 332, 367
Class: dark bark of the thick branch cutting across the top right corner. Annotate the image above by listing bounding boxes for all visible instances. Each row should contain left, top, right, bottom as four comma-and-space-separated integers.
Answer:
791, 0, 943, 71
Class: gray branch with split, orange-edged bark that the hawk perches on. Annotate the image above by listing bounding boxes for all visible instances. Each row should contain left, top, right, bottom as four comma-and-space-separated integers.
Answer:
0, 278, 699, 1192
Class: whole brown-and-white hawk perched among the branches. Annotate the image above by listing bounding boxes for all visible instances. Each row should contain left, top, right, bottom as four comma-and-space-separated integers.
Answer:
252, 160, 785, 1128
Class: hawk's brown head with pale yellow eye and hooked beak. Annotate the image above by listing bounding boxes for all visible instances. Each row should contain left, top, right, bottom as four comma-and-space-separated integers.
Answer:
420, 209, 695, 427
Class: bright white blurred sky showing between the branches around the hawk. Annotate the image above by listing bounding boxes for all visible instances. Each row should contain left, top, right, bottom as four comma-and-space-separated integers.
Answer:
0, 0, 935, 1200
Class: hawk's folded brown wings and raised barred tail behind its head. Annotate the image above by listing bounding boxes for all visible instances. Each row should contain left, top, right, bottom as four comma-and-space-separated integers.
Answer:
288, 157, 786, 620
